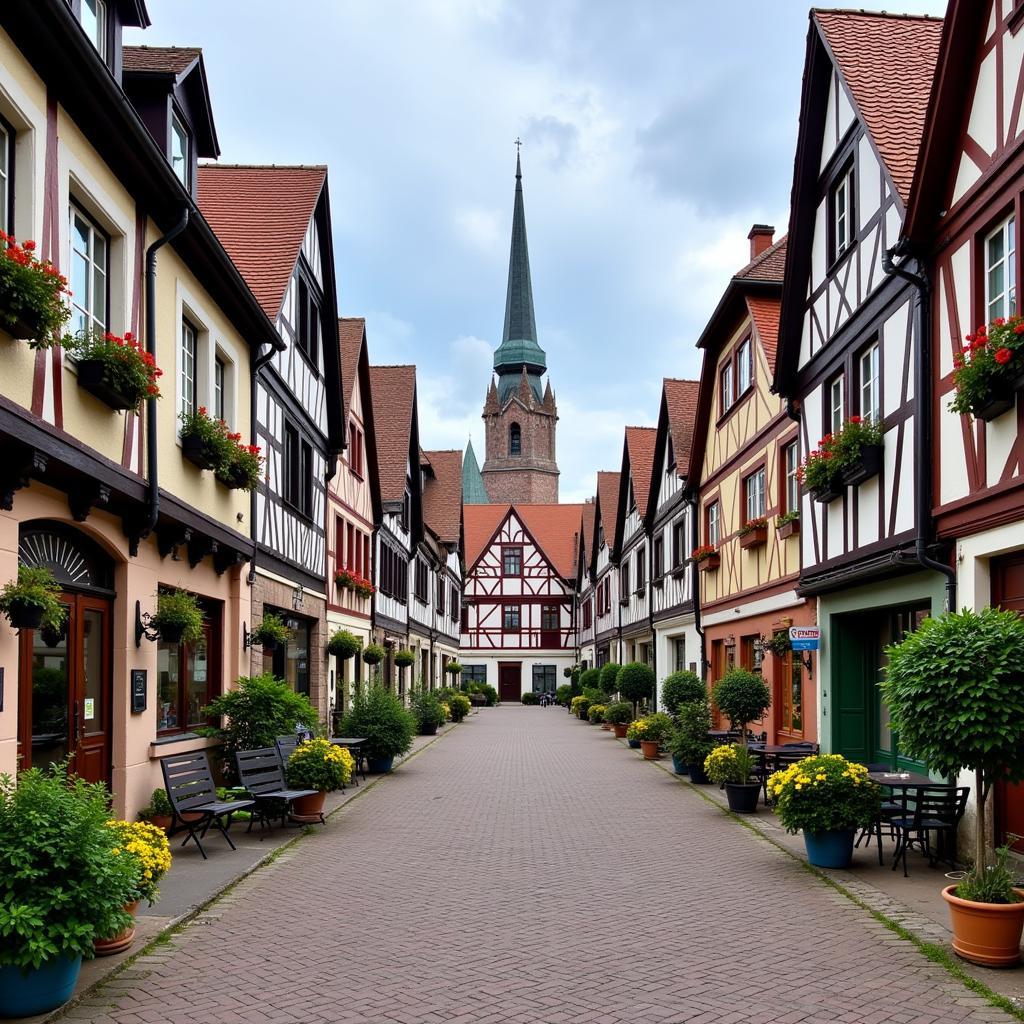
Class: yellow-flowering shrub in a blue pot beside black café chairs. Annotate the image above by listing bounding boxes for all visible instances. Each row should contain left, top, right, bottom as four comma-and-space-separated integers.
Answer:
767, 754, 881, 867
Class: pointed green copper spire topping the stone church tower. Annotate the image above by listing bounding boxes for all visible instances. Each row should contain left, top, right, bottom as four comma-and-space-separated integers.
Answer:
495, 149, 548, 403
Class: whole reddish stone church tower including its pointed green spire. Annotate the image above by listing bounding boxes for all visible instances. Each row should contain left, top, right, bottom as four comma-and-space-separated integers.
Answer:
481, 155, 558, 504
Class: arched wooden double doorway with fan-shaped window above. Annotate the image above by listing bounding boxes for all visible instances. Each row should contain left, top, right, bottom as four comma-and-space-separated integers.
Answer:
17, 520, 114, 782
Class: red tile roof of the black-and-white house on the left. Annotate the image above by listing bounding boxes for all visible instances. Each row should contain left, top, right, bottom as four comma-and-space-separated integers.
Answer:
198, 164, 327, 323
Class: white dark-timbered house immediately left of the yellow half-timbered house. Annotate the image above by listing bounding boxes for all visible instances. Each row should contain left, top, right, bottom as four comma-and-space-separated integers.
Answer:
646, 378, 703, 696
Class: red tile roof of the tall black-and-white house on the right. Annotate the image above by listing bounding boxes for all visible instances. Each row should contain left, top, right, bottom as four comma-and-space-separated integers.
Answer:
813, 10, 942, 206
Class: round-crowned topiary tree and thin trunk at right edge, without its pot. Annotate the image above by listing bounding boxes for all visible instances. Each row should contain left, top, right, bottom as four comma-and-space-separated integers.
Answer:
881, 608, 1024, 872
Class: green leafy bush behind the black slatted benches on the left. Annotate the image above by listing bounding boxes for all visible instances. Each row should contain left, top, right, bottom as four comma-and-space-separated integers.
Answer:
196, 673, 315, 782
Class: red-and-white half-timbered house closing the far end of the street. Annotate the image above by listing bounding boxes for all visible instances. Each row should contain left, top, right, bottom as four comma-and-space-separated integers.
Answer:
461, 505, 583, 700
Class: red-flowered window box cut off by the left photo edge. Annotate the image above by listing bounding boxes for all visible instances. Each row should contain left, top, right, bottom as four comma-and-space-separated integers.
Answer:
0, 231, 71, 348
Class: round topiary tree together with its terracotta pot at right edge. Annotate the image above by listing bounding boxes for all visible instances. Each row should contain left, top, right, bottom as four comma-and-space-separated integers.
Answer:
881, 608, 1024, 967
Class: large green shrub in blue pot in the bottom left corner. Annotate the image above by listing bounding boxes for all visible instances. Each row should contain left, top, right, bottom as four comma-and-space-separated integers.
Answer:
0, 765, 138, 1017
